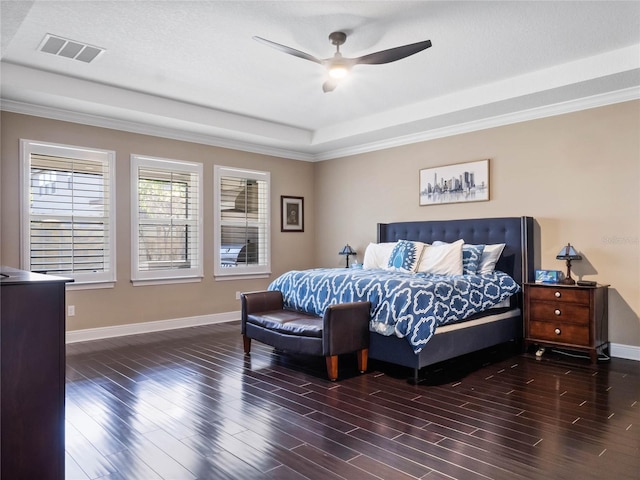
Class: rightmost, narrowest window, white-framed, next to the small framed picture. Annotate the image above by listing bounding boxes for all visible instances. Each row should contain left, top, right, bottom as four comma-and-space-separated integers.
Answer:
214, 166, 271, 277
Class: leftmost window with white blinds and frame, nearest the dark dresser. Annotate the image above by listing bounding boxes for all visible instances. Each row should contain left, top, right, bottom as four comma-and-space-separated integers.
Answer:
20, 140, 116, 284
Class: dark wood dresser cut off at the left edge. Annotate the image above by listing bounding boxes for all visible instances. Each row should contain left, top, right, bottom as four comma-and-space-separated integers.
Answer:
0, 267, 71, 480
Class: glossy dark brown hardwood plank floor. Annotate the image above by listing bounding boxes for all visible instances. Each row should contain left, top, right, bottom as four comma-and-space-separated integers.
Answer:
66, 322, 640, 480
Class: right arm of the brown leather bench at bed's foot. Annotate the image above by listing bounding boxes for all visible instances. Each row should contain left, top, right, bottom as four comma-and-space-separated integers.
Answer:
322, 302, 371, 356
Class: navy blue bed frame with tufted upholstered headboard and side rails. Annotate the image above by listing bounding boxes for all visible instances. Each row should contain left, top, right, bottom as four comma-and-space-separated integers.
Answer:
369, 217, 538, 381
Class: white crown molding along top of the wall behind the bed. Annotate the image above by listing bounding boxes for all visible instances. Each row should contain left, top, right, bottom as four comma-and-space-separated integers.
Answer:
314, 87, 640, 161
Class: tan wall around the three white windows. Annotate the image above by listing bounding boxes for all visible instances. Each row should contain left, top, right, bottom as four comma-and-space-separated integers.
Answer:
0, 112, 315, 330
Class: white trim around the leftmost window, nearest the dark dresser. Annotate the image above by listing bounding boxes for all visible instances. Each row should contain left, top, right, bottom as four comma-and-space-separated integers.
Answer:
20, 139, 117, 290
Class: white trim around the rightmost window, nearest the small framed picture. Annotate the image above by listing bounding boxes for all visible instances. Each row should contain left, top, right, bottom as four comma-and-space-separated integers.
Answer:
213, 165, 271, 280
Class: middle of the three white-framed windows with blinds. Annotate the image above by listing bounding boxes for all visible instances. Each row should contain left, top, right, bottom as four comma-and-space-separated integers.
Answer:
131, 155, 202, 284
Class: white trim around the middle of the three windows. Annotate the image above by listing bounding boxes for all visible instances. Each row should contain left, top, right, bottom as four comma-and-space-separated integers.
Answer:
130, 154, 204, 286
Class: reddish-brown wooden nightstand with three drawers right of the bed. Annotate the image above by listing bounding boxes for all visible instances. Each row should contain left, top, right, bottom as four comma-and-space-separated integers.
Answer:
524, 283, 609, 363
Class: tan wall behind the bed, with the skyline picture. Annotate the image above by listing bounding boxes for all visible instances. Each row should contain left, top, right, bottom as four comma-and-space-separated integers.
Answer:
315, 101, 640, 346
